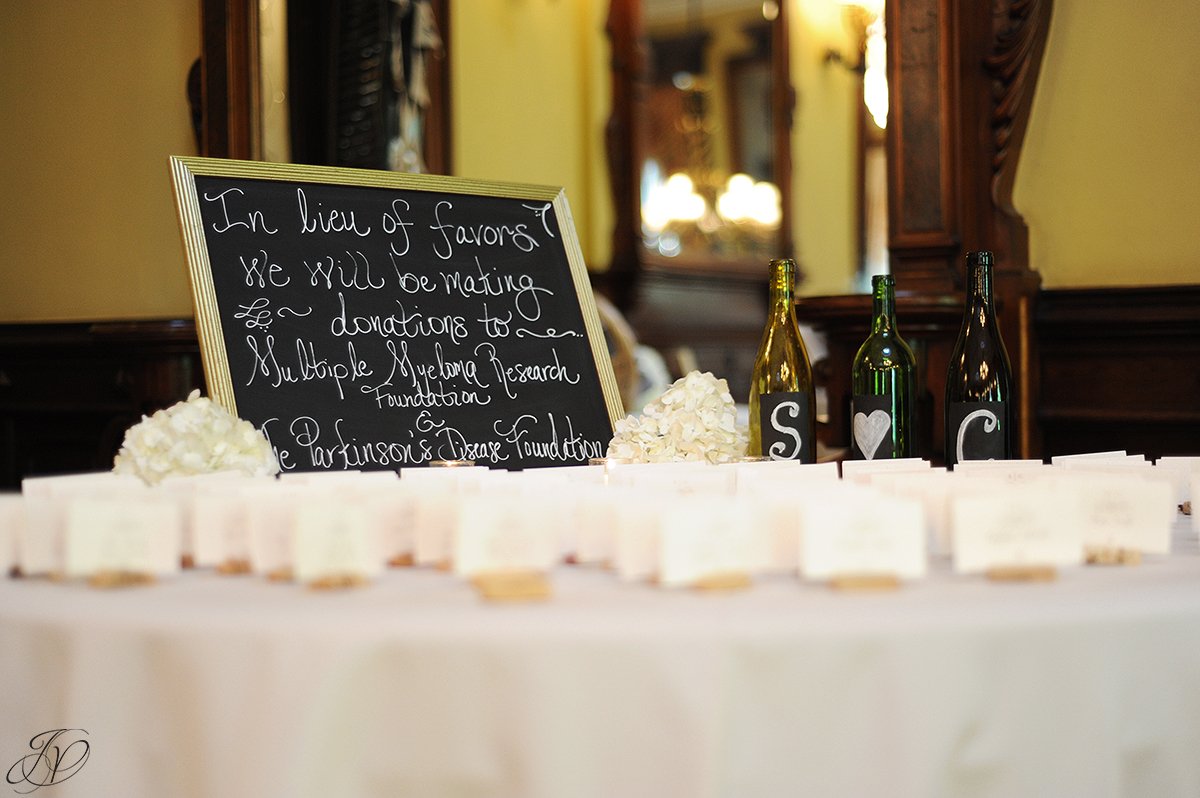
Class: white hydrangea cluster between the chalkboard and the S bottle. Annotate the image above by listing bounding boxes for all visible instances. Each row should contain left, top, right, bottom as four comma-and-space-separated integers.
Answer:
608, 371, 749, 463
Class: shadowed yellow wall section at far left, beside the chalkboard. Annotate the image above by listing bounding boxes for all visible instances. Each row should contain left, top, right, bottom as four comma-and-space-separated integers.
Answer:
0, 0, 200, 322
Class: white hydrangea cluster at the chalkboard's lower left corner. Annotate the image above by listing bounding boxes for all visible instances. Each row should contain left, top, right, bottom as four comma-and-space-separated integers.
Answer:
113, 390, 280, 485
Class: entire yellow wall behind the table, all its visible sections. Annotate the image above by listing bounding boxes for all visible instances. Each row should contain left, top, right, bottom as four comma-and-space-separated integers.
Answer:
0, 0, 1200, 322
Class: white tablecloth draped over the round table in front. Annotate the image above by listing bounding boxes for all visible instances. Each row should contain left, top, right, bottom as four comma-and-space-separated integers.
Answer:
0, 524, 1200, 798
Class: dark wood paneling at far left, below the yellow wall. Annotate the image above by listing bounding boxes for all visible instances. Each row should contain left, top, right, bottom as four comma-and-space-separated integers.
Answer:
0, 320, 204, 488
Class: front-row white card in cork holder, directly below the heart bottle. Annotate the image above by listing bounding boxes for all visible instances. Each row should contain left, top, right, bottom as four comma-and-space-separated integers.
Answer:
800, 491, 928, 580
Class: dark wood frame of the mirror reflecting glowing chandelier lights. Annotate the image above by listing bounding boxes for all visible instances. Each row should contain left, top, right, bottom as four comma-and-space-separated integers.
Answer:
596, 0, 796, 310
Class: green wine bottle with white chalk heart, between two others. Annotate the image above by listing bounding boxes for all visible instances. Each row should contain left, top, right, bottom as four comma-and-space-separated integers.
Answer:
850, 275, 917, 460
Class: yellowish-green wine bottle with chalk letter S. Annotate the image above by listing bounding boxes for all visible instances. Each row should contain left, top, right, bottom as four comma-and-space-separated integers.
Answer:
749, 258, 817, 463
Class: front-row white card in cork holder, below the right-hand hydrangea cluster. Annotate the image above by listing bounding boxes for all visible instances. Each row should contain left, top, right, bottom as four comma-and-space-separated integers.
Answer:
658, 499, 768, 587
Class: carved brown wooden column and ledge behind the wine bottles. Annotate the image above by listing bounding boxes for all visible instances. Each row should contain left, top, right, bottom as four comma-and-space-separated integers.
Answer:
798, 0, 1051, 457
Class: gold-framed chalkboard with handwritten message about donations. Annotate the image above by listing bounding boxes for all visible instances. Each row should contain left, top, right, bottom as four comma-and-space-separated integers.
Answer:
170, 157, 622, 472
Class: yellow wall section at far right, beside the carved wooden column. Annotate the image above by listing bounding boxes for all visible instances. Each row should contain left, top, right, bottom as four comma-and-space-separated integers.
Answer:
1014, 0, 1200, 288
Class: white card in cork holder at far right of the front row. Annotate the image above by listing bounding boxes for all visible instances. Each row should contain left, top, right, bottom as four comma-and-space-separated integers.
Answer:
1058, 470, 1177, 558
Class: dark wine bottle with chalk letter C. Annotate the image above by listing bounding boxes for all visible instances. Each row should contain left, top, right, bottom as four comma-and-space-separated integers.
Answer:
946, 252, 1016, 466
